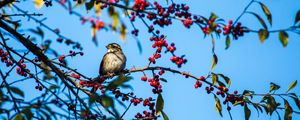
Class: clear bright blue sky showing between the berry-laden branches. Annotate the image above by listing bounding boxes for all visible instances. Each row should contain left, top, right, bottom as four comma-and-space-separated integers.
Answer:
1, 0, 300, 120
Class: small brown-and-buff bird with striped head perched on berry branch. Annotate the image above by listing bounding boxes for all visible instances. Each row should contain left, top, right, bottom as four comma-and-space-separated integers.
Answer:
99, 43, 126, 76
